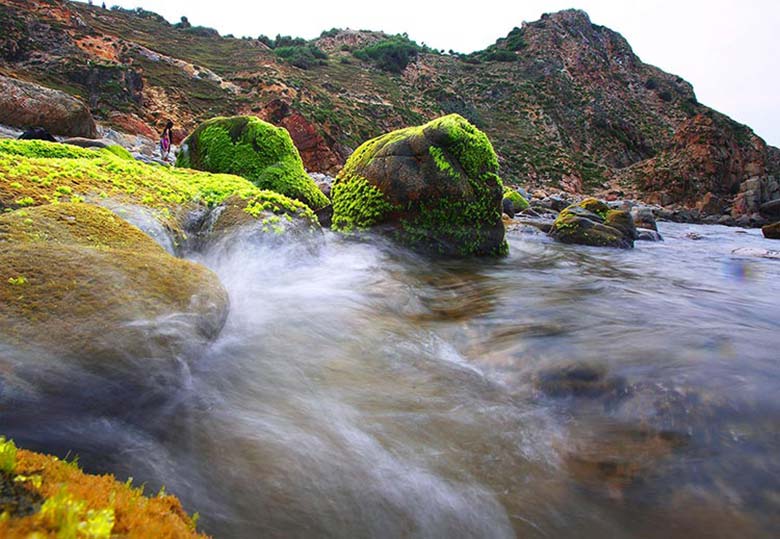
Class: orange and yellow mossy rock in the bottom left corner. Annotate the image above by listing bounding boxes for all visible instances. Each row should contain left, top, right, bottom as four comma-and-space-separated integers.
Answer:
0, 437, 206, 539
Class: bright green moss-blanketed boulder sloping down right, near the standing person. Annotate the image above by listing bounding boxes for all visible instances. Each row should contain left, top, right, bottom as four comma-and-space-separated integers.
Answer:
176, 116, 329, 210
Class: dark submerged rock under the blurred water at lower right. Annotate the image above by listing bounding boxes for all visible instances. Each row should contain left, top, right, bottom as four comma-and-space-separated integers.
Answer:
535, 363, 625, 398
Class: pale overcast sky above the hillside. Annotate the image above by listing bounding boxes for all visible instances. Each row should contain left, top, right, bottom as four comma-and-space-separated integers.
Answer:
76, 0, 780, 147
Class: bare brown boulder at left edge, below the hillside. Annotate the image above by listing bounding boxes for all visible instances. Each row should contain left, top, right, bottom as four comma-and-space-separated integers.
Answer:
0, 75, 97, 138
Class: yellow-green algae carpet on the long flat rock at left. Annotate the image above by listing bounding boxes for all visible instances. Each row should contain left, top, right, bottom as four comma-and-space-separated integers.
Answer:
0, 140, 316, 225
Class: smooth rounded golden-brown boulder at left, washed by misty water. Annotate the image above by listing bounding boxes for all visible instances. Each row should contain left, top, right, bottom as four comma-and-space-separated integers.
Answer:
0, 203, 228, 374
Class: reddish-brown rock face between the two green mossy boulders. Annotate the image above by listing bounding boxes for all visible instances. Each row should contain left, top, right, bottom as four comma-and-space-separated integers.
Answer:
260, 99, 344, 174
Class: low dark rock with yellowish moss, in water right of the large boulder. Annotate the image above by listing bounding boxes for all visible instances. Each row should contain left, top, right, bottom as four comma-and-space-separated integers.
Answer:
550, 198, 637, 249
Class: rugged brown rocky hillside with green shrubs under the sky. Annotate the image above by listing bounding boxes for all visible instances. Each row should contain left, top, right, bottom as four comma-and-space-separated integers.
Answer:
0, 0, 780, 224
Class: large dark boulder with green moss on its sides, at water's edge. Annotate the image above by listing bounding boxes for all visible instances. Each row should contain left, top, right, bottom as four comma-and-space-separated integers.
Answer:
332, 114, 508, 255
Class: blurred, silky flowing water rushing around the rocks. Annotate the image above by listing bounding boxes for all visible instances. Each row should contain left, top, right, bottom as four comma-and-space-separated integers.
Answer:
0, 223, 780, 538
